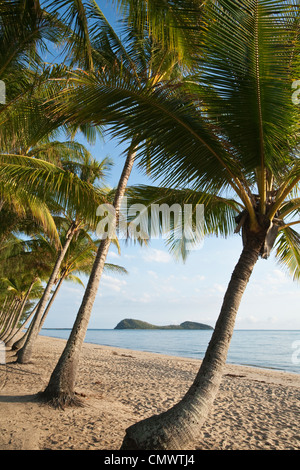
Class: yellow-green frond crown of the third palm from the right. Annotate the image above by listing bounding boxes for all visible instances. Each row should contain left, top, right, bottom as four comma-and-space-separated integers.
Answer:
0, 86, 108, 243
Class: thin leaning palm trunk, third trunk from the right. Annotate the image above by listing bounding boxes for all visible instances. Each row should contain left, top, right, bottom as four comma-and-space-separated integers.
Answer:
17, 223, 77, 364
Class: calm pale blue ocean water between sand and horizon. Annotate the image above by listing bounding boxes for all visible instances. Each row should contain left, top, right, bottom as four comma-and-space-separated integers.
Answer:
41, 329, 300, 374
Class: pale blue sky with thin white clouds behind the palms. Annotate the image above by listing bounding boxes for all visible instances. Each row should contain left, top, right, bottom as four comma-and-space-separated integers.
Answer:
44, 1, 300, 330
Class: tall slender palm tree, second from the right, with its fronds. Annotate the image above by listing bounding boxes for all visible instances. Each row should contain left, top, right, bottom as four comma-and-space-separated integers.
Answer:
41, 0, 192, 406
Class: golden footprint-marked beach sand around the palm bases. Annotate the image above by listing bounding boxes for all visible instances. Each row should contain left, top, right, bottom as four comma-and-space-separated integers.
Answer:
0, 336, 300, 450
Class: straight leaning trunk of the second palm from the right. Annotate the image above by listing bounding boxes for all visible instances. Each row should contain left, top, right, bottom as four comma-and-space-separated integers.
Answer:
40, 144, 136, 407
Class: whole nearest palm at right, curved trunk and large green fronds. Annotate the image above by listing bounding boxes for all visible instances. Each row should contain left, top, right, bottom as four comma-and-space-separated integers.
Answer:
45, 0, 300, 450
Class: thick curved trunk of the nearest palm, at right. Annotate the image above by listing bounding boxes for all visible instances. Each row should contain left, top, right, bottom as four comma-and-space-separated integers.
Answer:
121, 229, 265, 450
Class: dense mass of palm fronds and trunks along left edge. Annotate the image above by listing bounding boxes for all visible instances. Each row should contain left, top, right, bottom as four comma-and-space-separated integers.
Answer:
0, 0, 124, 360
